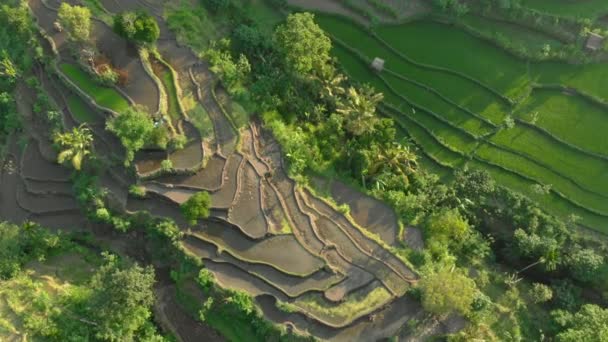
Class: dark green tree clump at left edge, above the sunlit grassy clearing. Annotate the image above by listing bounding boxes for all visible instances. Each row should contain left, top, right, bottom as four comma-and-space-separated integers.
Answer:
0, 222, 62, 280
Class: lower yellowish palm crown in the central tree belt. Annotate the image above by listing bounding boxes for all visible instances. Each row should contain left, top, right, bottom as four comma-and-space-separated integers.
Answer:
367, 143, 418, 184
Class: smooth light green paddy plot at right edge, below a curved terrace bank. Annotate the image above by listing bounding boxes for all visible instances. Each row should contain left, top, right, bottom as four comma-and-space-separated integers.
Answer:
517, 89, 608, 156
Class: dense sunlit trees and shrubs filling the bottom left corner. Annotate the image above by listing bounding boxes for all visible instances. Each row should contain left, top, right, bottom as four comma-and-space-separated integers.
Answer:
0, 222, 164, 341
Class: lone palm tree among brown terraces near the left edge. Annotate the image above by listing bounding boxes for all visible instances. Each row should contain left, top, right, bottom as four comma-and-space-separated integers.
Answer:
53, 125, 93, 170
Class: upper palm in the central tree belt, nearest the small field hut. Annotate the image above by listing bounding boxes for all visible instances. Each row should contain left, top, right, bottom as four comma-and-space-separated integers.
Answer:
336, 86, 384, 135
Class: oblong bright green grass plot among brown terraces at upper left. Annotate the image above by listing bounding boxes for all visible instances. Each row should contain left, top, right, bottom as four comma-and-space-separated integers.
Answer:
60, 63, 129, 113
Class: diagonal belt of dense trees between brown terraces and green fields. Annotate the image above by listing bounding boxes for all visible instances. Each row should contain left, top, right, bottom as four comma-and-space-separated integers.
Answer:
188, 2, 606, 340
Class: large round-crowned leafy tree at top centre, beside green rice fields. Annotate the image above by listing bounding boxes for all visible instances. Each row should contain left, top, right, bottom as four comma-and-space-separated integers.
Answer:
274, 13, 331, 77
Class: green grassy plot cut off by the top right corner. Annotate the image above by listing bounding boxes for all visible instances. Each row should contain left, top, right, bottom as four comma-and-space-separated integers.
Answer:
522, 0, 608, 19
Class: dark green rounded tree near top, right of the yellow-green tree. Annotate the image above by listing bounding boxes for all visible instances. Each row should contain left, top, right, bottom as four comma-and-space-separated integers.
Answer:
114, 11, 160, 44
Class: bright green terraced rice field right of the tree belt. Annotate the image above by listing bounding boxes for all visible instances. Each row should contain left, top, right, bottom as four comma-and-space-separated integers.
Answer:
316, 14, 608, 232
